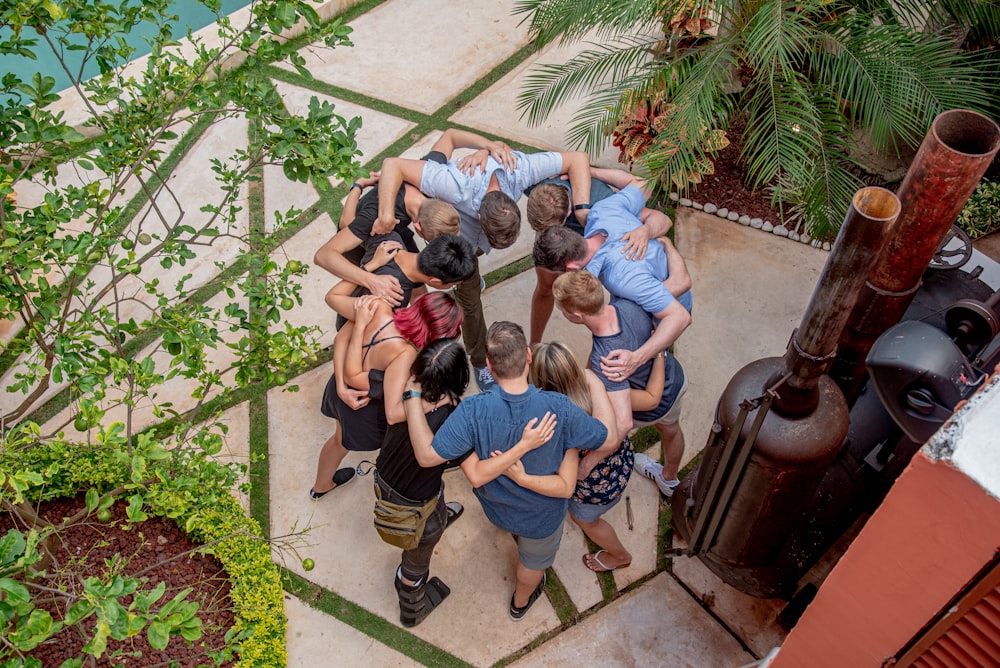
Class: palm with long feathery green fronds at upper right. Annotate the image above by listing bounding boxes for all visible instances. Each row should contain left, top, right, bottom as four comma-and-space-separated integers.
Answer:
515, 0, 1000, 239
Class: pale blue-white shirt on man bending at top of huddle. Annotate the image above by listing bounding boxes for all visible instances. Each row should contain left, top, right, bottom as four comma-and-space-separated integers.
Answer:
420, 151, 562, 253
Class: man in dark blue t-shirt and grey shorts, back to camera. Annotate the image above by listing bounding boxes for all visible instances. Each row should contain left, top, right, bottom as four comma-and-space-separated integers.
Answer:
407, 321, 608, 621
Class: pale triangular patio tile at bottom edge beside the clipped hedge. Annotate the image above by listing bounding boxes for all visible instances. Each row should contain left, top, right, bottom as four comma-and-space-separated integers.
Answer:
285, 594, 420, 668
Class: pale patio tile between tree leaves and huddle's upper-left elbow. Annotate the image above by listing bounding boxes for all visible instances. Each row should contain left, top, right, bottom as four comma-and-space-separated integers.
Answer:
271, 213, 339, 350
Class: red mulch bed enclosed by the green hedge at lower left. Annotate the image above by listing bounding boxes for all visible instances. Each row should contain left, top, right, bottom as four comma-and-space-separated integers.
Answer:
0, 495, 235, 668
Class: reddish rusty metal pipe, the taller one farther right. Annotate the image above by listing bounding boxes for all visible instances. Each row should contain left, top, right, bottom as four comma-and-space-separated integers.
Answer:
830, 109, 1000, 403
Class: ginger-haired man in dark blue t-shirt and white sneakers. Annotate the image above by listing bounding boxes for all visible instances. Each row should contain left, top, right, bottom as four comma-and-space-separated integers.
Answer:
552, 271, 687, 498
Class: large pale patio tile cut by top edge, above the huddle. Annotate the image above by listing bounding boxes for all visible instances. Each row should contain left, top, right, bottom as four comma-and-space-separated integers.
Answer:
284, 0, 527, 113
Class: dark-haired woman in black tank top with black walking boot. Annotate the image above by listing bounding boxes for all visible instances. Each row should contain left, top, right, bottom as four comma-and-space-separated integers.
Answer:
375, 339, 469, 627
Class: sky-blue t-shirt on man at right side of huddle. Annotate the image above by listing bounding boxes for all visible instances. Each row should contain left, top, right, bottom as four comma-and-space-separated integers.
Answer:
583, 186, 691, 314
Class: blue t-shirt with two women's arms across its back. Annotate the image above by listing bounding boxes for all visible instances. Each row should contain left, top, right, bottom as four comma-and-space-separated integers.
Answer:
432, 385, 608, 538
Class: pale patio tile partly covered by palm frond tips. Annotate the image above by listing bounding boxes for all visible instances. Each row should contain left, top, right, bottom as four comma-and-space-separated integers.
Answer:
450, 28, 624, 168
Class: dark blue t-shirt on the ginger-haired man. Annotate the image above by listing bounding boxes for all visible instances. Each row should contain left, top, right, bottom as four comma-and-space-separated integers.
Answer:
590, 297, 684, 422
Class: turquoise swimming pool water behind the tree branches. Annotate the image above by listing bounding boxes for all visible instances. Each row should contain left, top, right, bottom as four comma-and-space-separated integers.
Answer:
0, 0, 251, 96
